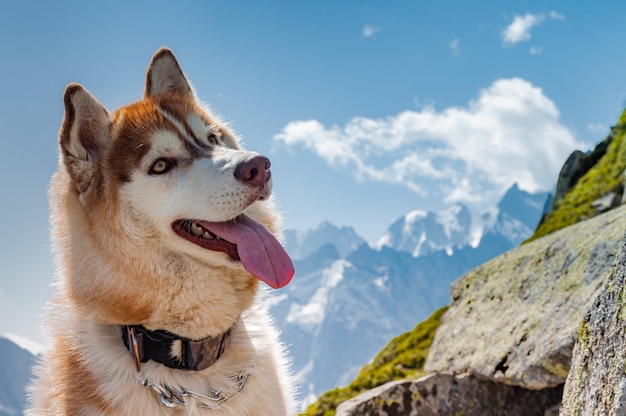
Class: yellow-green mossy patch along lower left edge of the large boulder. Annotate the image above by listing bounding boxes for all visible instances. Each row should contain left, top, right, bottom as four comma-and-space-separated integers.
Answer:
303, 306, 448, 416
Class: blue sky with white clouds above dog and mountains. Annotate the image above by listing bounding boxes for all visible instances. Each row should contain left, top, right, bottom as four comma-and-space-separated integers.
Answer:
0, 0, 626, 341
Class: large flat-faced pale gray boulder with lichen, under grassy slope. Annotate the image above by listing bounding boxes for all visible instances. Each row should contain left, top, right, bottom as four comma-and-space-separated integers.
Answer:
425, 207, 626, 390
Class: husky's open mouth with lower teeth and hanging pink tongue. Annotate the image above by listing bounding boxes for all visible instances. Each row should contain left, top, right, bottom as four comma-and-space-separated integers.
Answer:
172, 214, 294, 289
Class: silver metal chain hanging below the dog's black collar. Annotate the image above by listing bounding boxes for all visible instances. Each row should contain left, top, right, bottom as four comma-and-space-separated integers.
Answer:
141, 365, 254, 409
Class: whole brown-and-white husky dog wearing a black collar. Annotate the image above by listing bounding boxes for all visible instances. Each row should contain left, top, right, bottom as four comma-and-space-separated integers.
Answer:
26, 49, 296, 416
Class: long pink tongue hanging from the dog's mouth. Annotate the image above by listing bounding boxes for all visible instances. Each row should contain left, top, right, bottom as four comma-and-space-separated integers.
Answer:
203, 215, 294, 289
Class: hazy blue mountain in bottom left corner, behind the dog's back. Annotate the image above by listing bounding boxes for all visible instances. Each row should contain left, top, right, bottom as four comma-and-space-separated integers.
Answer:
0, 337, 37, 416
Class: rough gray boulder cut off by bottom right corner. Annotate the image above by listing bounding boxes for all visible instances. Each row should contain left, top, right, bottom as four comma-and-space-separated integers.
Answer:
561, 232, 626, 416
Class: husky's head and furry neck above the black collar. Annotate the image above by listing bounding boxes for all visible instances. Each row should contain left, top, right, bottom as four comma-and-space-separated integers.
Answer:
51, 49, 293, 334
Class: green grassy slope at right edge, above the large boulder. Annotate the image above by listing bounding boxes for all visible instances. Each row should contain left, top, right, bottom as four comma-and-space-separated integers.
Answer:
526, 111, 626, 242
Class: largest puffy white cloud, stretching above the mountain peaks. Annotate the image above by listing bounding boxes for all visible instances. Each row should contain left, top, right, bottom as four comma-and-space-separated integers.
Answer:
274, 78, 584, 208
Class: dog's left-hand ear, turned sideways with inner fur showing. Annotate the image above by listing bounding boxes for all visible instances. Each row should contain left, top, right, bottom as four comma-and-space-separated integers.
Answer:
60, 84, 110, 193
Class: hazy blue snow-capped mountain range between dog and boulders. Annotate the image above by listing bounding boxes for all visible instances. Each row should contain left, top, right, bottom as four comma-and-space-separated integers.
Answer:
270, 185, 548, 403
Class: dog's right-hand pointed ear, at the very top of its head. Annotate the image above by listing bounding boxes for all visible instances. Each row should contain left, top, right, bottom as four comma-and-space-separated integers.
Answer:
144, 48, 193, 97
